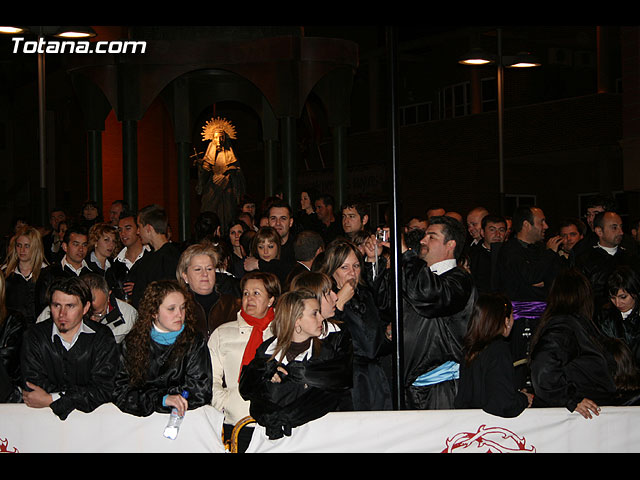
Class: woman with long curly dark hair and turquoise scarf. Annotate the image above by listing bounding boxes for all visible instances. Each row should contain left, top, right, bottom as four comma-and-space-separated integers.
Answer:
114, 280, 212, 417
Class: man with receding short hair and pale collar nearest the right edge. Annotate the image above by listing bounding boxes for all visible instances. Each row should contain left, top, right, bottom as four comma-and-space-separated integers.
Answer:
576, 211, 640, 309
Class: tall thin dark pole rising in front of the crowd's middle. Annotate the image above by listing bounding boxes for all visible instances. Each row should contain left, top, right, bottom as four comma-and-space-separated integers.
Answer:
387, 27, 404, 410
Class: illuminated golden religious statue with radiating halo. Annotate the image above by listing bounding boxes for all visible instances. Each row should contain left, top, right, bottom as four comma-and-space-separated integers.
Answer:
195, 117, 246, 231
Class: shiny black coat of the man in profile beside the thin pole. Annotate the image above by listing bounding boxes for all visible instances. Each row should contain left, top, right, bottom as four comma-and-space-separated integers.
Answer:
402, 250, 478, 387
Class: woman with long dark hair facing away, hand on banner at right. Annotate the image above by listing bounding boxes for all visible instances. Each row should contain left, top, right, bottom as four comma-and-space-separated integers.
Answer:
531, 269, 616, 418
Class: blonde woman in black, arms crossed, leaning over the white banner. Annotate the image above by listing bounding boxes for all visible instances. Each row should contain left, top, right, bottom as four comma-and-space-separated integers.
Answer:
240, 289, 353, 440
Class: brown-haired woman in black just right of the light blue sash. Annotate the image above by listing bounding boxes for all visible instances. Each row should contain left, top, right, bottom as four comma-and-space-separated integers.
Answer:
455, 294, 533, 418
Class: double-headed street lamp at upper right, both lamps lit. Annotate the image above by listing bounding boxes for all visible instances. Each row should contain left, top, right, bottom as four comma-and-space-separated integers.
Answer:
458, 28, 541, 215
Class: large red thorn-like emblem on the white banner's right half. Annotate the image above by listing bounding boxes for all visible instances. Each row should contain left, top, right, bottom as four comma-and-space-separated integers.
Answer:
442, 425, 536, 453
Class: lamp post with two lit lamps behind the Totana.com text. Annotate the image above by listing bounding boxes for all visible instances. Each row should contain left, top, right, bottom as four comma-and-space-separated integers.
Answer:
0, 26, 96, 225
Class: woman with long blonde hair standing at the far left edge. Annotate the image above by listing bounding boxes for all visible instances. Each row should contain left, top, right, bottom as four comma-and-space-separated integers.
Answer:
4, 225, 47, 323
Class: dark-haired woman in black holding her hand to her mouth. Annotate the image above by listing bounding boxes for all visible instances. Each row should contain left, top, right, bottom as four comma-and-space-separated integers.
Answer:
314, 240, 391, 410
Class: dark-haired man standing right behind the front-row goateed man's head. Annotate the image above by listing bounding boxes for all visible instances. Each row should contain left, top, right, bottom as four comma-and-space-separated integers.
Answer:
35, 225, 91, 316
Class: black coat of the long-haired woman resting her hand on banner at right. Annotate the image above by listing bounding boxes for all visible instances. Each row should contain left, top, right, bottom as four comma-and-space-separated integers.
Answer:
531, 315, 616, 412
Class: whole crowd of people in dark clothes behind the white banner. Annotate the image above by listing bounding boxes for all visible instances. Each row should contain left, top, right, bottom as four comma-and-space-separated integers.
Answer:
0, 190, 640, 448
